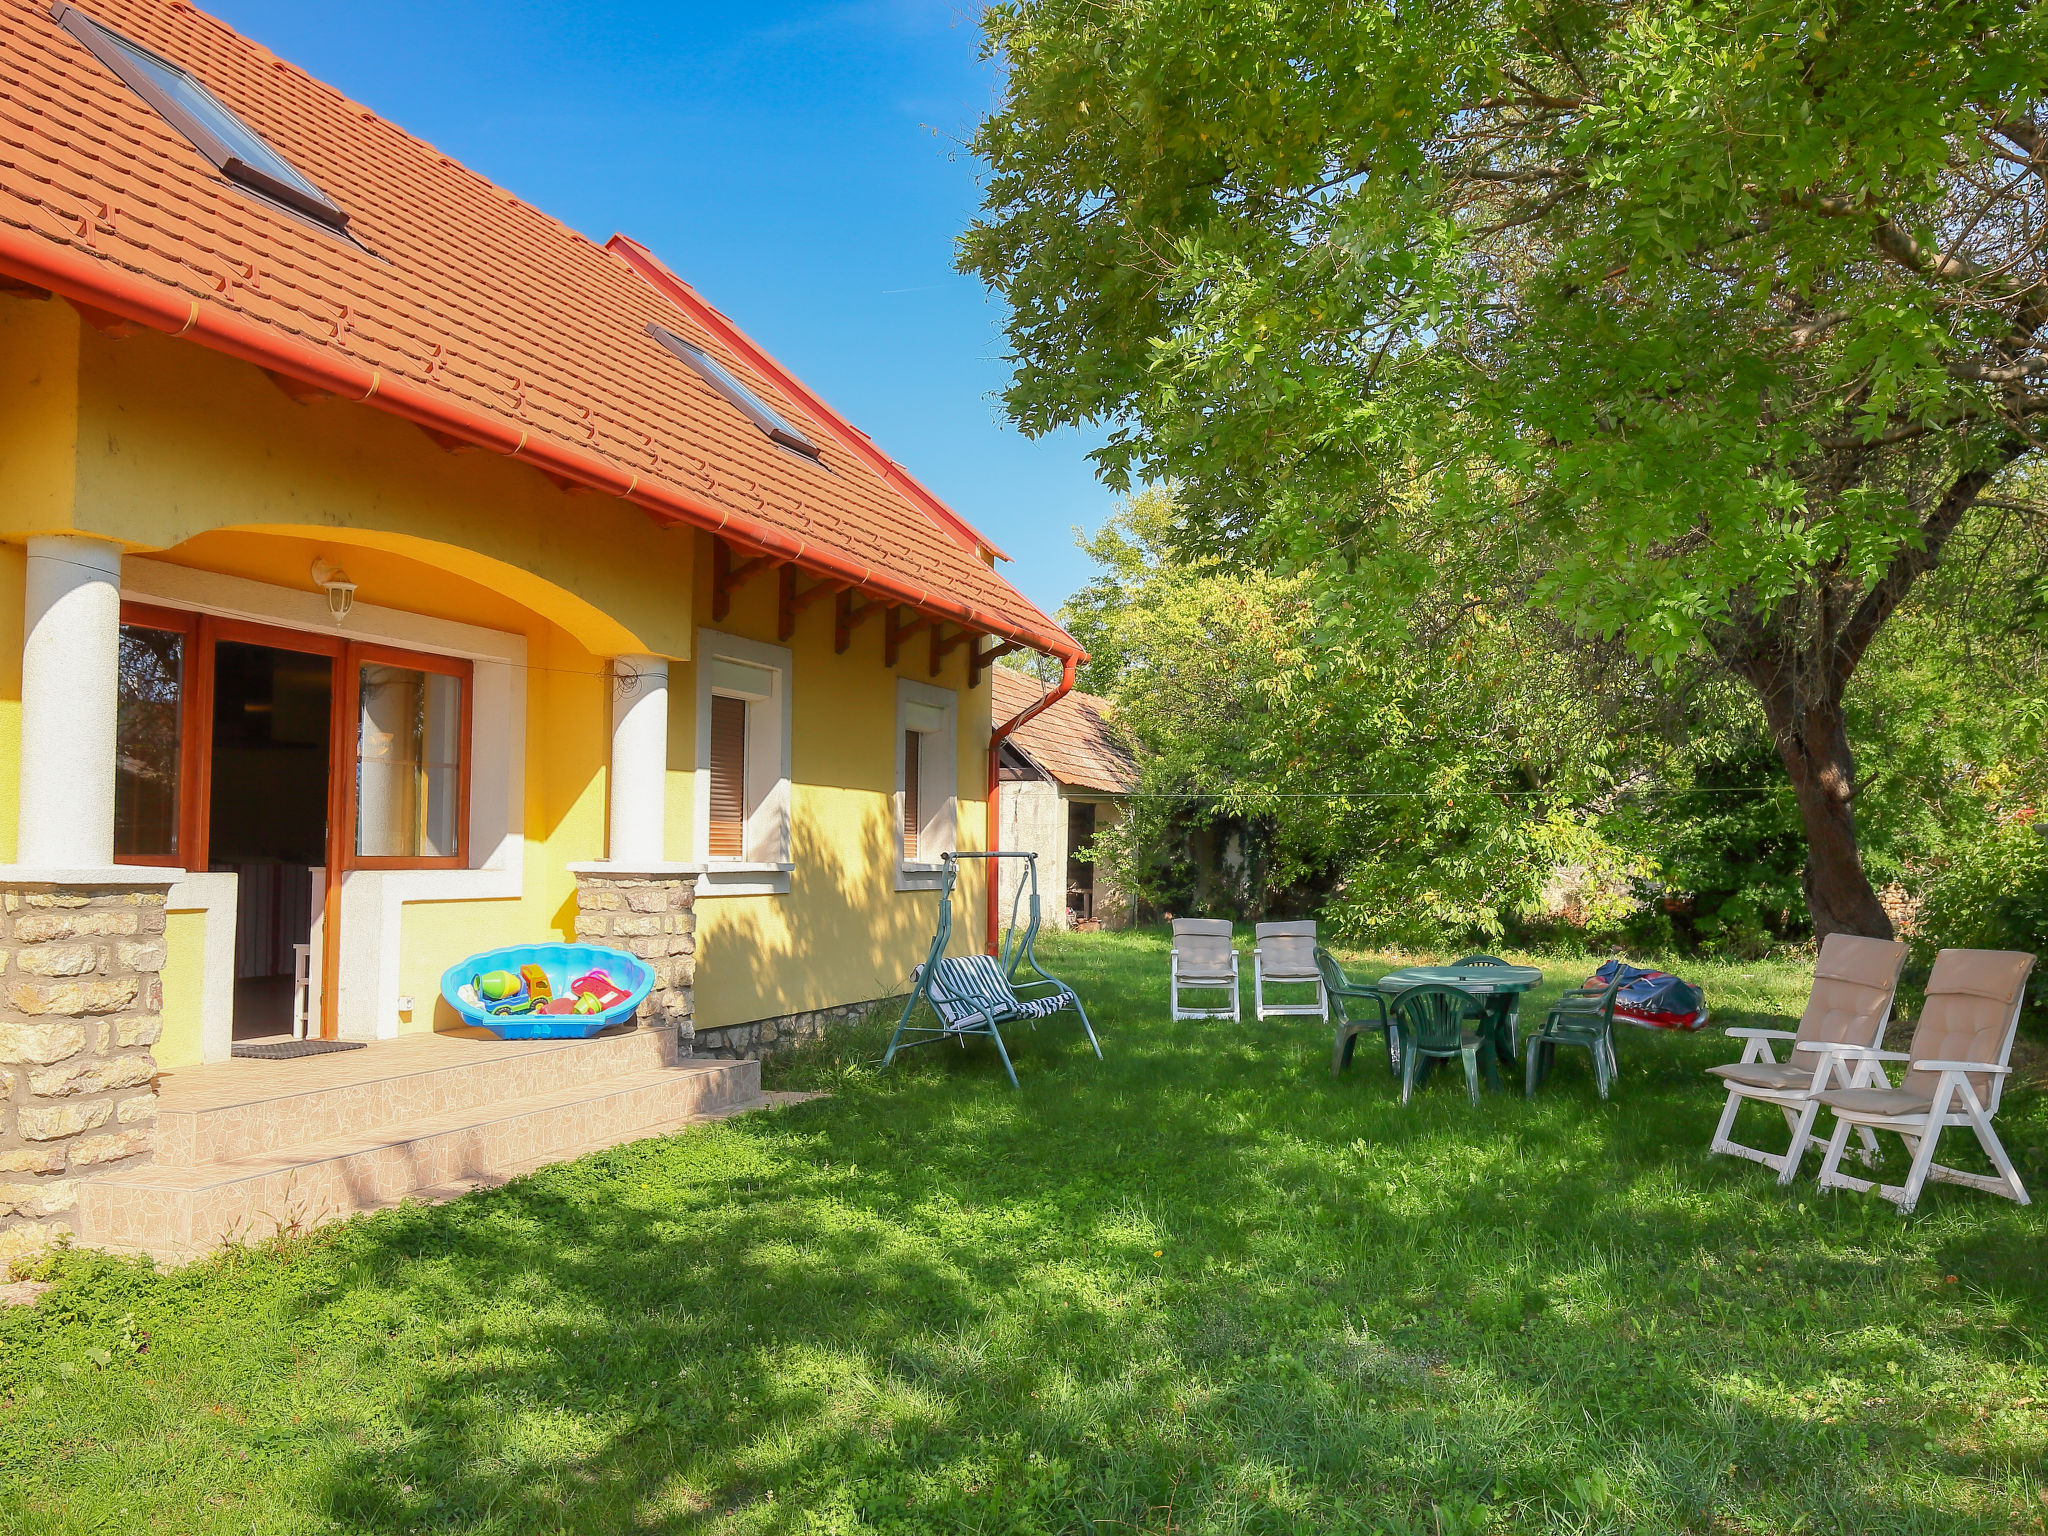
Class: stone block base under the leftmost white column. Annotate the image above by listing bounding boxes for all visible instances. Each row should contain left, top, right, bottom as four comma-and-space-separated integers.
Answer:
0, 885, 166, 1280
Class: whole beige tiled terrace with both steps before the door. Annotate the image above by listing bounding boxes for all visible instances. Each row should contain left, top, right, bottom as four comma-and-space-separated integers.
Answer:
78, 1028, 770, 1262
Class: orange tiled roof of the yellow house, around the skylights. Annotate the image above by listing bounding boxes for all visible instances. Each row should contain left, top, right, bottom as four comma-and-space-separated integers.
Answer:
0, 0, 1077, 653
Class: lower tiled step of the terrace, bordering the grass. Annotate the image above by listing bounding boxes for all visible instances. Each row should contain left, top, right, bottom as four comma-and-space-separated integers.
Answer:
78, 1036, 764, 1260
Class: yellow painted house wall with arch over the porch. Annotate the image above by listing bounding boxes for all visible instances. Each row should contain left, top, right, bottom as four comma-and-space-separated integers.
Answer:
0, 299, 989, 1063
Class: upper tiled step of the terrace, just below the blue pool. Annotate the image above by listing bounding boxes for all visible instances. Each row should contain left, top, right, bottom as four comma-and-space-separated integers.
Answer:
156, 1028, 676, 1167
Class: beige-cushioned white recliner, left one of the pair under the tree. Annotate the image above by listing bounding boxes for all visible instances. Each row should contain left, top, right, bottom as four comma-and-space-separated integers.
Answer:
1708, 934, 1907, 1184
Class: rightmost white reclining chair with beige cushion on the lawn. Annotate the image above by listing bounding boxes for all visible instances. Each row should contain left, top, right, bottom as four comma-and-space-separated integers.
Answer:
1821, 950, 2034, 1210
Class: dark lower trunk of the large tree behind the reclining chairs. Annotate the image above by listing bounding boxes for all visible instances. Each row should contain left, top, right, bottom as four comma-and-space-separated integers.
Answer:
1761, 688, 1892, 940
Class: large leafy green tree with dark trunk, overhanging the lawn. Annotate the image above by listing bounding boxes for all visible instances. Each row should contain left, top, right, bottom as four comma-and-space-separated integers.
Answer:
963, 0, 2048, 936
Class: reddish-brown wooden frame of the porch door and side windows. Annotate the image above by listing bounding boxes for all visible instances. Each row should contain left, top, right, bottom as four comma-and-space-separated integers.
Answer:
119, 602, 477, 1040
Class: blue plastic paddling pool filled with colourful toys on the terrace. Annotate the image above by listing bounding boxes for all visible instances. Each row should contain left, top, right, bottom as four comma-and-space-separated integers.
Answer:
440, 944, 653, 1040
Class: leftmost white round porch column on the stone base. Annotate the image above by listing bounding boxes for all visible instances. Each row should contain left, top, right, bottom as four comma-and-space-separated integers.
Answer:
14, 537, 121, 868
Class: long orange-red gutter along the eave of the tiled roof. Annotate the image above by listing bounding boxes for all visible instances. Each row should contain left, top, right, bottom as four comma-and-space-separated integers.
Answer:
0, 223, 1085, 657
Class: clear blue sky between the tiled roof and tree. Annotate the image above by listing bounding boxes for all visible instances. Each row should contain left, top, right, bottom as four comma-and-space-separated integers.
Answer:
203, 0, 1112, 610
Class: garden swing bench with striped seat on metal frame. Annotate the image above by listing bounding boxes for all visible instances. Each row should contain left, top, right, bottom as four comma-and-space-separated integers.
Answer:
883, 850, 1102, 1087
